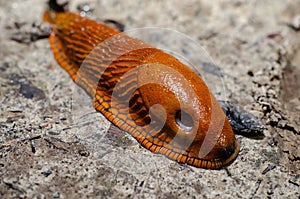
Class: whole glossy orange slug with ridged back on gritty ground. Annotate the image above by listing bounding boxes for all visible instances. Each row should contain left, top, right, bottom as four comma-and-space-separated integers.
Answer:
44, 11, 239, 169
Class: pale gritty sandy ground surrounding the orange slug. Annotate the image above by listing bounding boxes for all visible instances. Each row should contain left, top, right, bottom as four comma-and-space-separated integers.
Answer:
0, 0, 300, 198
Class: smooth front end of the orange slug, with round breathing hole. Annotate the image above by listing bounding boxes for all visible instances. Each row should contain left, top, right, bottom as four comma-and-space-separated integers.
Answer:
134, 51, 239, 169
